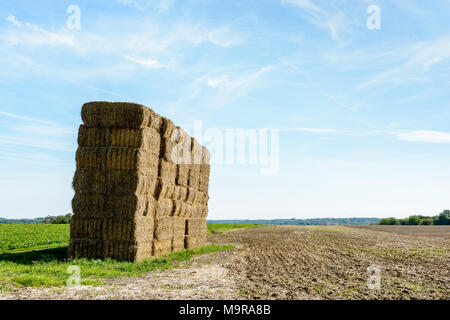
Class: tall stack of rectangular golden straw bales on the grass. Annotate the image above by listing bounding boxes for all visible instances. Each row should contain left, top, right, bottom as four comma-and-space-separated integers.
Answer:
69, 102, 210, 261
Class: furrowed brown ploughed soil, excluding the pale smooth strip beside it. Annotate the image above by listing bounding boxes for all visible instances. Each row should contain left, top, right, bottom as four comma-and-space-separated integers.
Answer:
209, 226, 450, 299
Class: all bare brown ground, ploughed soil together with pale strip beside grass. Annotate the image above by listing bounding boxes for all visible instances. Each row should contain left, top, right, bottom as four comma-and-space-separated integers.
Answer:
3, 226, 450, 300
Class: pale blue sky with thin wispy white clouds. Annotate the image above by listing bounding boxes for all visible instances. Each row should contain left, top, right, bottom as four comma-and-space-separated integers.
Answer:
0, 0, 450, 219
